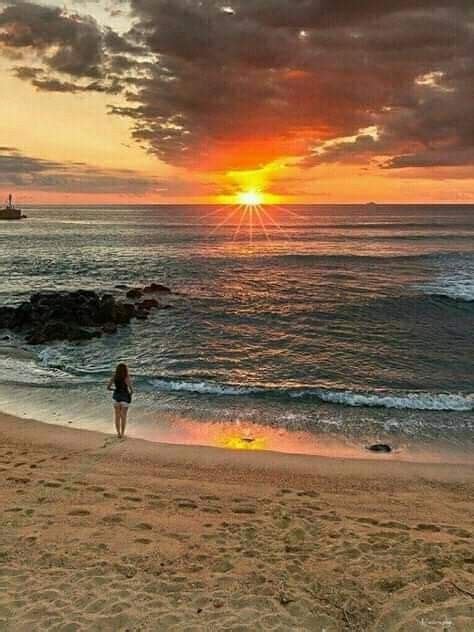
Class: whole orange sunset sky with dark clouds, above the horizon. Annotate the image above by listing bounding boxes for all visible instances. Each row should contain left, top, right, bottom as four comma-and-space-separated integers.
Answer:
0, 0, 474, 204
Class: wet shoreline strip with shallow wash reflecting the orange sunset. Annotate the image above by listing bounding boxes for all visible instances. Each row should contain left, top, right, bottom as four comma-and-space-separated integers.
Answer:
0, 345, 474, 465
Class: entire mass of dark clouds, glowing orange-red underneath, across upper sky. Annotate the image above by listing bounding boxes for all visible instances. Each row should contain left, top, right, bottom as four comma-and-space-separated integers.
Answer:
0, 0, 474, 170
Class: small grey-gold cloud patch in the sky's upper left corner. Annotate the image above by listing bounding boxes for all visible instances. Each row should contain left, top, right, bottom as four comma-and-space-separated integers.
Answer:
0, 0, 143, 94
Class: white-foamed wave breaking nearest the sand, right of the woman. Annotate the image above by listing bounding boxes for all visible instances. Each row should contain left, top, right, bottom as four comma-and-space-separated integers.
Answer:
150, 379, 474, 411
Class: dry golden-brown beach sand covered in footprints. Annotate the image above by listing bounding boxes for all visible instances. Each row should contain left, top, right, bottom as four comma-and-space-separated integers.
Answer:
0, 415, 474, 632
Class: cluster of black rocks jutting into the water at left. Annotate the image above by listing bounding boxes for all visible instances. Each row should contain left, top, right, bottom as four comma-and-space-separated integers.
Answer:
0, 284, 170, 345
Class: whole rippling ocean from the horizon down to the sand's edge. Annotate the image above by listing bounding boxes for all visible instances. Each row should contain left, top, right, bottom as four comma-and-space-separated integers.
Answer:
0, 205, 474, 456
